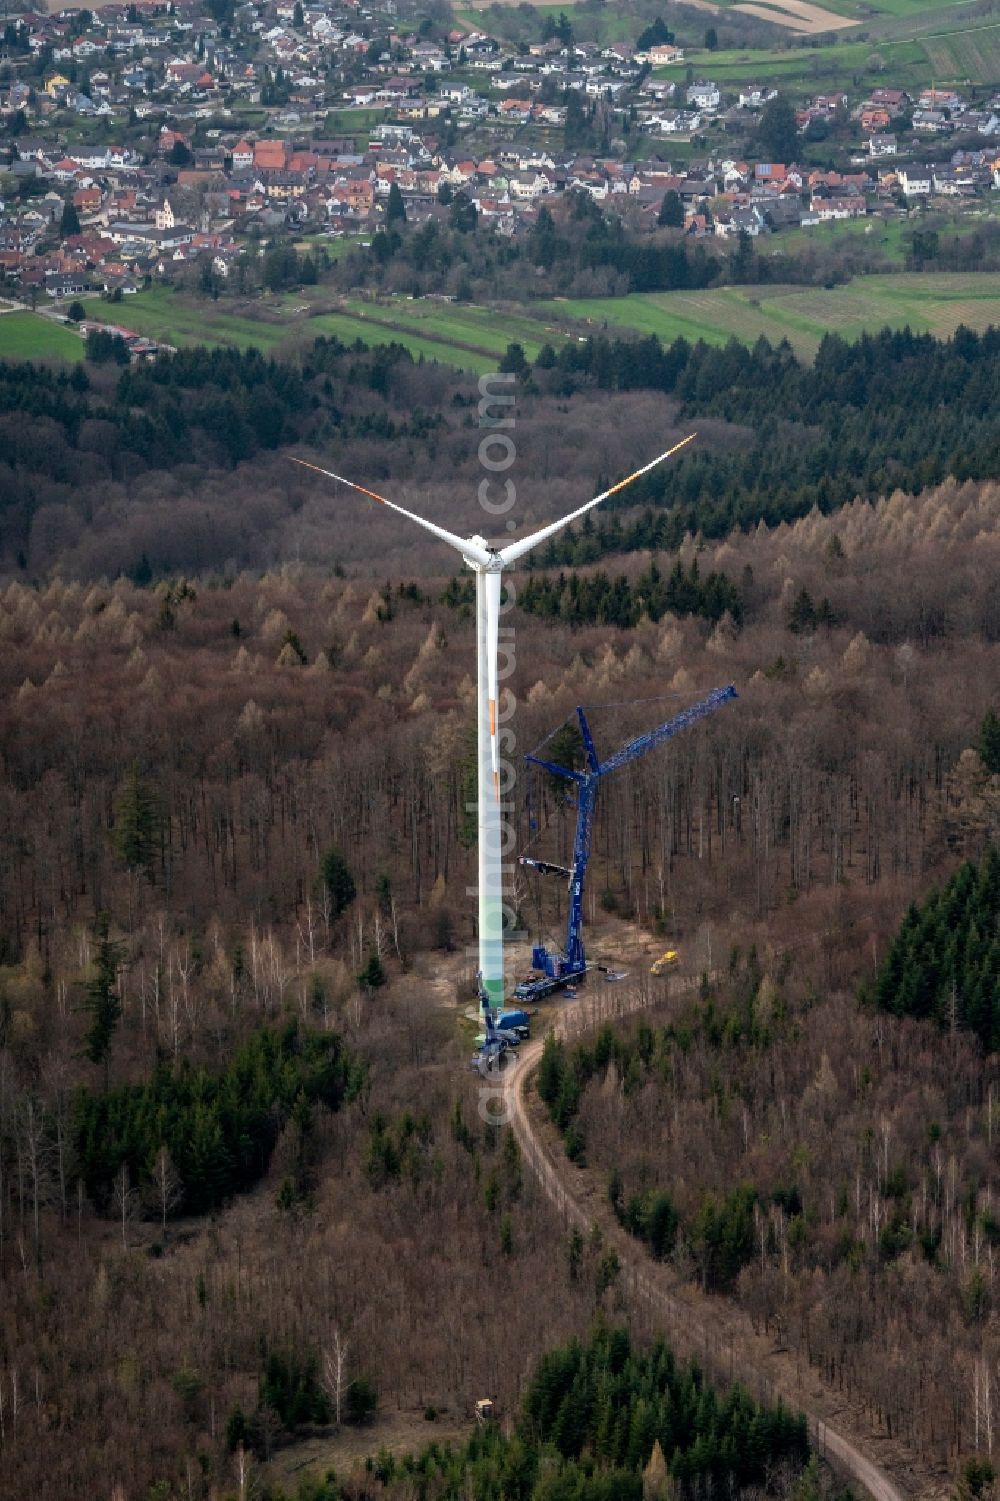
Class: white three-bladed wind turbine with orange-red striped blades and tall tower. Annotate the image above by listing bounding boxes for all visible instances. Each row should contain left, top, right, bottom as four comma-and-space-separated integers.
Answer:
293, 432, 695, 1009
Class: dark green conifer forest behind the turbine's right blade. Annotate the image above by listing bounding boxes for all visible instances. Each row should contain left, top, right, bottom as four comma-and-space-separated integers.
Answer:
532, 329, 1000, 567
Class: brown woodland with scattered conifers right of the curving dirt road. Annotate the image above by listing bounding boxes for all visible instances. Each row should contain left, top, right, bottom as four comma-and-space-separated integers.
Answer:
539, 924, 997, 1476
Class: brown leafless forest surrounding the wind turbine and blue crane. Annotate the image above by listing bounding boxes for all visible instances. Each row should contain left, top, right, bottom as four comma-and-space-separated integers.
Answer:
0, 465, 1000, 1496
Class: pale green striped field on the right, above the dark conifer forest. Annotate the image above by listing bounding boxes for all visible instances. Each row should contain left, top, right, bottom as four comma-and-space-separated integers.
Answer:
539, 272, 1000, 359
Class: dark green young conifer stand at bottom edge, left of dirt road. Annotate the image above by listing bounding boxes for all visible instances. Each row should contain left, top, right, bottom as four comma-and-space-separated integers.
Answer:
244, 1325, 827, 1501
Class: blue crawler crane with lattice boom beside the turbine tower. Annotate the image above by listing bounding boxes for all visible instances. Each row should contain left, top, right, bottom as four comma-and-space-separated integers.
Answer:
514, 684, 737, 1001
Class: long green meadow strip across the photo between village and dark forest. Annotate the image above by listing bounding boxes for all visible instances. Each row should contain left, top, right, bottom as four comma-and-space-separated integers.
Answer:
40, 267, 1000, 374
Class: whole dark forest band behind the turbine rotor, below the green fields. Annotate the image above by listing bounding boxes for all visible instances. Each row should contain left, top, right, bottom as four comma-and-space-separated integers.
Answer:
0, 322, 1000, 585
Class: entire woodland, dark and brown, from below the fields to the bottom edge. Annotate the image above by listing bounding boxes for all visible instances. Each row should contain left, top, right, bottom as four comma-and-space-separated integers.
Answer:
0, 319, 1000, 1501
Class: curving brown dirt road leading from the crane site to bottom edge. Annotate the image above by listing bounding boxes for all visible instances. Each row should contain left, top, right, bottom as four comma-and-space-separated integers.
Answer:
494, 982, 952, 1501
